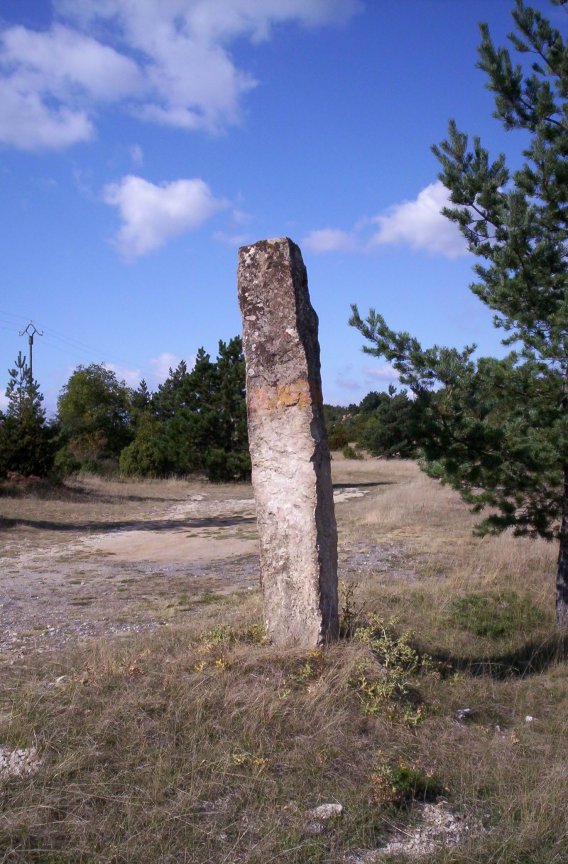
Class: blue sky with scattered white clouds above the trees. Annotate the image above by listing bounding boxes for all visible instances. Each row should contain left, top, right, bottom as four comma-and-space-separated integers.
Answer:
0, 0, 566, 410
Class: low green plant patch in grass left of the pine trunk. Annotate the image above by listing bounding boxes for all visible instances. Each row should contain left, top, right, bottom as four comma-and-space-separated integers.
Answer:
450, 591, 545, 639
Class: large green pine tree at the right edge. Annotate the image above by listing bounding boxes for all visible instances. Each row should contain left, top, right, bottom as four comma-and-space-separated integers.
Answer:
350, 0, 568, 626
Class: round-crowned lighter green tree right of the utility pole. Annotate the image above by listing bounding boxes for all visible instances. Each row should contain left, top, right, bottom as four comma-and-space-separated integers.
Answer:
58, 363, 133, 470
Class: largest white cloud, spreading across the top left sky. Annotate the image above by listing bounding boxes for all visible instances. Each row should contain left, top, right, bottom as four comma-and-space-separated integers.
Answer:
0, 0, 361, 149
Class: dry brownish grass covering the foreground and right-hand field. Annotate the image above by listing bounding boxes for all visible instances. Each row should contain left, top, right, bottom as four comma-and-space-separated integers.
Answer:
0, 458, 568, 864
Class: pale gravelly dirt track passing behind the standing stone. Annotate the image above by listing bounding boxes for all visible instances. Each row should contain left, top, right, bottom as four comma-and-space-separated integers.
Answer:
0, 462, 414, 663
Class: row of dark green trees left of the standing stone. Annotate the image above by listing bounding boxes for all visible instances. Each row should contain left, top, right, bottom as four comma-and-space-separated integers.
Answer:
0, 337, 250, 481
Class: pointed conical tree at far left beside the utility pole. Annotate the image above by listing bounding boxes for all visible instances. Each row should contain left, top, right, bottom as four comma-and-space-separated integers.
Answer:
0, 352, 53, 477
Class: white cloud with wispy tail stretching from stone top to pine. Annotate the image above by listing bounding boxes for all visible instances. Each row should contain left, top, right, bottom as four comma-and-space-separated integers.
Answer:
302, 180, 467, 259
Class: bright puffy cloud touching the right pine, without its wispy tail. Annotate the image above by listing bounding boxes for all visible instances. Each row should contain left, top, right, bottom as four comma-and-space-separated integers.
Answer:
371, 180, 467, 258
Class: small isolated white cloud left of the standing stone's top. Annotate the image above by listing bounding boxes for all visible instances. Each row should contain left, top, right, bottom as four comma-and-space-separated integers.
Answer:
103, 175, 228, 258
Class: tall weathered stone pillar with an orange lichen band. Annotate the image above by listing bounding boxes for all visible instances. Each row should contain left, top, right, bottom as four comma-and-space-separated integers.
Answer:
238, 237, 338, 647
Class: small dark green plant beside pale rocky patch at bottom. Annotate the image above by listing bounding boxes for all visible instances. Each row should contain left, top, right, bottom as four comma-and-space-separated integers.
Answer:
369, 761, 445, 807
